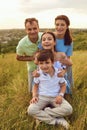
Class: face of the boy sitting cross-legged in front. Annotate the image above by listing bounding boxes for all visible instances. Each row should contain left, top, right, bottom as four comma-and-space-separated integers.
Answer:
38, 59, 53, 74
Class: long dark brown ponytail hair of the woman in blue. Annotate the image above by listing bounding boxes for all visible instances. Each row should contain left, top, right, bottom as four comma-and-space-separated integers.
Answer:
55, 15, 72, 45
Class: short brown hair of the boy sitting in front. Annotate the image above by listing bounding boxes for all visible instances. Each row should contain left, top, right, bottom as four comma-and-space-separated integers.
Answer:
37, 50, 54, 62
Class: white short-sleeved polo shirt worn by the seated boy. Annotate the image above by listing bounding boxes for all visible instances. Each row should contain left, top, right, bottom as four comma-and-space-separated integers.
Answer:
34, 67, 67, 97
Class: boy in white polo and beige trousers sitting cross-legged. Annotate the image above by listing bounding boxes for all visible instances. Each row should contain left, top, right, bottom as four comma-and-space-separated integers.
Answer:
28, 50, 72, 129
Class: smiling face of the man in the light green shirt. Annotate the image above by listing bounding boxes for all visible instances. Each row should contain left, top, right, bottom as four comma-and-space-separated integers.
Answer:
25, 21, 39, 41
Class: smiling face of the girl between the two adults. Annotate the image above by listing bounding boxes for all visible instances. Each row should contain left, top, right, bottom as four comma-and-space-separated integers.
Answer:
42, 33, 56, 50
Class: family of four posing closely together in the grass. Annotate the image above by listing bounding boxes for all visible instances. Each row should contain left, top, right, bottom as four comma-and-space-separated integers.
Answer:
16, 15, 73, 129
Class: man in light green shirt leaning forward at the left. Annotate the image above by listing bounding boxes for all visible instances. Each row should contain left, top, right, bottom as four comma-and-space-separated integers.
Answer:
16, 18, 41, 92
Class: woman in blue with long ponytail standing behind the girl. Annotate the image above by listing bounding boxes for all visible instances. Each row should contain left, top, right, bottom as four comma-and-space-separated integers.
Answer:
54, 15, 73, 94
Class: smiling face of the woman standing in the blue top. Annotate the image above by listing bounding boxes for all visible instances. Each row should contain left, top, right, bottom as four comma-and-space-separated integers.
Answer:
55, 19, 67, 36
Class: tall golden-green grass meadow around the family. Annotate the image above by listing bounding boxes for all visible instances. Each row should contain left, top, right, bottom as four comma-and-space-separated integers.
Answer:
0, 51, 87, 130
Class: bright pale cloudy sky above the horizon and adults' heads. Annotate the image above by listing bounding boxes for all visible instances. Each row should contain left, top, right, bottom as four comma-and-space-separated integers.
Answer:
0, 0, 87, 29
